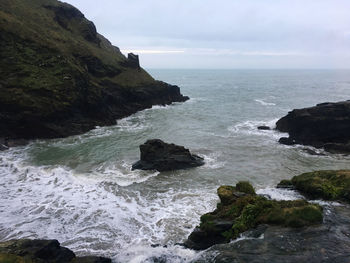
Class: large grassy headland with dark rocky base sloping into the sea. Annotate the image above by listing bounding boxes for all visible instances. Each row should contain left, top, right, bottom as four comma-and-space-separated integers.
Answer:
0, 0, 188, 139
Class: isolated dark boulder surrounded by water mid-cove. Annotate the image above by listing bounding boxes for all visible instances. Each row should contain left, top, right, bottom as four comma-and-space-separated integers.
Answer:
132, 139, 204, 171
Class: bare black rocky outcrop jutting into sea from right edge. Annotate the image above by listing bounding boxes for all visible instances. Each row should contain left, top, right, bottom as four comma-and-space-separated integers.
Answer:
276, 101, 350, 153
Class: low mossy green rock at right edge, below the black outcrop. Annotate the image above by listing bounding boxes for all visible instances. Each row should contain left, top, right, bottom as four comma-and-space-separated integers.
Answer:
278, 170, 350, 203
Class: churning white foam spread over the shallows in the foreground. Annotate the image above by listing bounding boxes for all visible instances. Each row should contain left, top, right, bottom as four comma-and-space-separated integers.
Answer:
0, 148, 217, 262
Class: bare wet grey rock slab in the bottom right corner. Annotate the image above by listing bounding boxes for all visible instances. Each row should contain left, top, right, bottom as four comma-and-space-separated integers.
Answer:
196, 206, 350, 263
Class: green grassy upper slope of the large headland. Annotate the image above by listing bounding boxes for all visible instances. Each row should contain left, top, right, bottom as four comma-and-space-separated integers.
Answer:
0, 0, 154, 87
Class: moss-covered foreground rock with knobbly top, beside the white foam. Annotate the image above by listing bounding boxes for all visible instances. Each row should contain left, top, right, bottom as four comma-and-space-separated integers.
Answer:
185, 182, 323, 250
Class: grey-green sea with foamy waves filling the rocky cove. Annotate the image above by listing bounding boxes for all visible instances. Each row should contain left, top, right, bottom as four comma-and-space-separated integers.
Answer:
0, 70, 350, 263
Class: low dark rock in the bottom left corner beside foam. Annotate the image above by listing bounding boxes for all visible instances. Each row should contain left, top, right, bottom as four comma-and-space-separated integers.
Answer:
0, 239, 112, 263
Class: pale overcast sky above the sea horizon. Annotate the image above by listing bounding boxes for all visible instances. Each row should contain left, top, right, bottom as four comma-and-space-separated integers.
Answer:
63, 0, 350, 69
